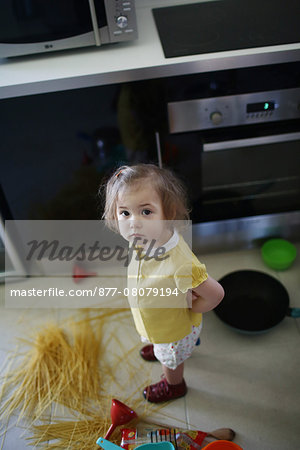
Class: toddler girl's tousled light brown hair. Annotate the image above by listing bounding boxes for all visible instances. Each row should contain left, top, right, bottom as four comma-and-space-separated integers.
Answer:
99, 164, 189, 232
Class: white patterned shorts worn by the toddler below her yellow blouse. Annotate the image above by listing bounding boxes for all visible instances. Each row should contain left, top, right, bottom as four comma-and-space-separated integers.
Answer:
142, 322, 202, 370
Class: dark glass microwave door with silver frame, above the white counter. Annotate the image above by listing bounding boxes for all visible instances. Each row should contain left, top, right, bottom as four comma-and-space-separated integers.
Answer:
0, 0, 101, 57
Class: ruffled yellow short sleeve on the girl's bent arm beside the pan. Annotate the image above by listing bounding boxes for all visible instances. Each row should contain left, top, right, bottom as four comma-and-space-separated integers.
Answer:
174, 260, 208, 293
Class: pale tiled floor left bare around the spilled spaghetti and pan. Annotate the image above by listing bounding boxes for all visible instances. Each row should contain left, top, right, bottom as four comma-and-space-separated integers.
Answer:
0, 245, 300, 450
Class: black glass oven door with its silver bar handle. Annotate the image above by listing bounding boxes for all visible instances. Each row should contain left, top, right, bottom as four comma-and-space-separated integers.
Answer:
199, 125, 300, 220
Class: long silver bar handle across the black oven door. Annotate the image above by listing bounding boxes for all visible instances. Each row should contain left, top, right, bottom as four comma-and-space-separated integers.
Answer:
203, 132, 300, 152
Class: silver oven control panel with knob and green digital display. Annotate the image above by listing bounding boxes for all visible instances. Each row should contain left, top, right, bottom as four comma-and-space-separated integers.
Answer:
168, 88, 300, 133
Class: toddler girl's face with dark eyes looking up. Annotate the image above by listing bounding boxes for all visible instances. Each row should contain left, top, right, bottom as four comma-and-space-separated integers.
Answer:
117, 180, 172, 248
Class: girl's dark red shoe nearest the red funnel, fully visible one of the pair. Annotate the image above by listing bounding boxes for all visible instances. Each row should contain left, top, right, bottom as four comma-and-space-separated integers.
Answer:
143, 378, 187, 403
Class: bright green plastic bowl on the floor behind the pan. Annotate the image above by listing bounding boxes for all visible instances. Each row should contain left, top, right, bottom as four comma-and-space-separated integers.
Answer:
261, 239, 297, 270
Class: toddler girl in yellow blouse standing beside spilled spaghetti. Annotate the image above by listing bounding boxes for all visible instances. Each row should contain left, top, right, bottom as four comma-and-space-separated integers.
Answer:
103, 164, 224, 403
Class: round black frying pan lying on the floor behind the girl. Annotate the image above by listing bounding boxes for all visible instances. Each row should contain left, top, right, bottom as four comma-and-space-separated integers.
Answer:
214, 270, 300, 333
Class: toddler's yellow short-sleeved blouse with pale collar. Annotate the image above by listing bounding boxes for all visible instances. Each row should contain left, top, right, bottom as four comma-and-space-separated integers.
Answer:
128, 232, 207, 344
